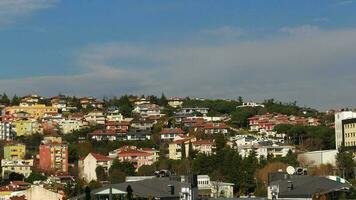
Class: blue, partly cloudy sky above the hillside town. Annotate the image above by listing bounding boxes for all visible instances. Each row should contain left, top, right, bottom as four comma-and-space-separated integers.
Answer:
0, 0, 356, 110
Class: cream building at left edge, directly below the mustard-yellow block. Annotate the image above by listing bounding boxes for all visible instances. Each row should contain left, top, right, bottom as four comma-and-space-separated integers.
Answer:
1, 159, 33, 179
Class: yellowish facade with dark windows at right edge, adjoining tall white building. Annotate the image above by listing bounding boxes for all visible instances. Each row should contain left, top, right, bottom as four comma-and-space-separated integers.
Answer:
342, 118, 356, 147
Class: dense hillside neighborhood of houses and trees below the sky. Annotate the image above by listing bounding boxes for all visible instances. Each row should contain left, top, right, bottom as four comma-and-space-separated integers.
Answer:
0, 94, 356, 200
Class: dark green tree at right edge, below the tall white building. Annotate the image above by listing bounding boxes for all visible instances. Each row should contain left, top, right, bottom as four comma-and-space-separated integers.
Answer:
336, 148, 355, 179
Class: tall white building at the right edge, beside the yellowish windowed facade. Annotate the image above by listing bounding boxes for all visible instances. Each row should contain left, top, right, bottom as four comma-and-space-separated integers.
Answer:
335, 111, 356, 149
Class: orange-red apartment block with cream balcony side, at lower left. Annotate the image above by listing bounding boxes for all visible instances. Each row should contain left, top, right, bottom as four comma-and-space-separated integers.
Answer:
39, 142, 68, 173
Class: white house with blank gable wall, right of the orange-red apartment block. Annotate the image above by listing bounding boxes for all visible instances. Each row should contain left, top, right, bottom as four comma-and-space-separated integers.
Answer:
81, 153, 113, 183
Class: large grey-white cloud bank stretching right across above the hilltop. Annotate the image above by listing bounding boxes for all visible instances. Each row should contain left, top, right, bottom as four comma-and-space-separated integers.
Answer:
0, 26, 356, 108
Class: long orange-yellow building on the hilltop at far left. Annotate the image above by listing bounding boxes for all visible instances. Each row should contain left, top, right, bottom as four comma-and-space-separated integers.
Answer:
5, 104, 58, 119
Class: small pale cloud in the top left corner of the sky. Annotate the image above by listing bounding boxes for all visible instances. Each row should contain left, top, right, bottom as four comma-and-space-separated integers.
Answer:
0, 0, 59, 25
